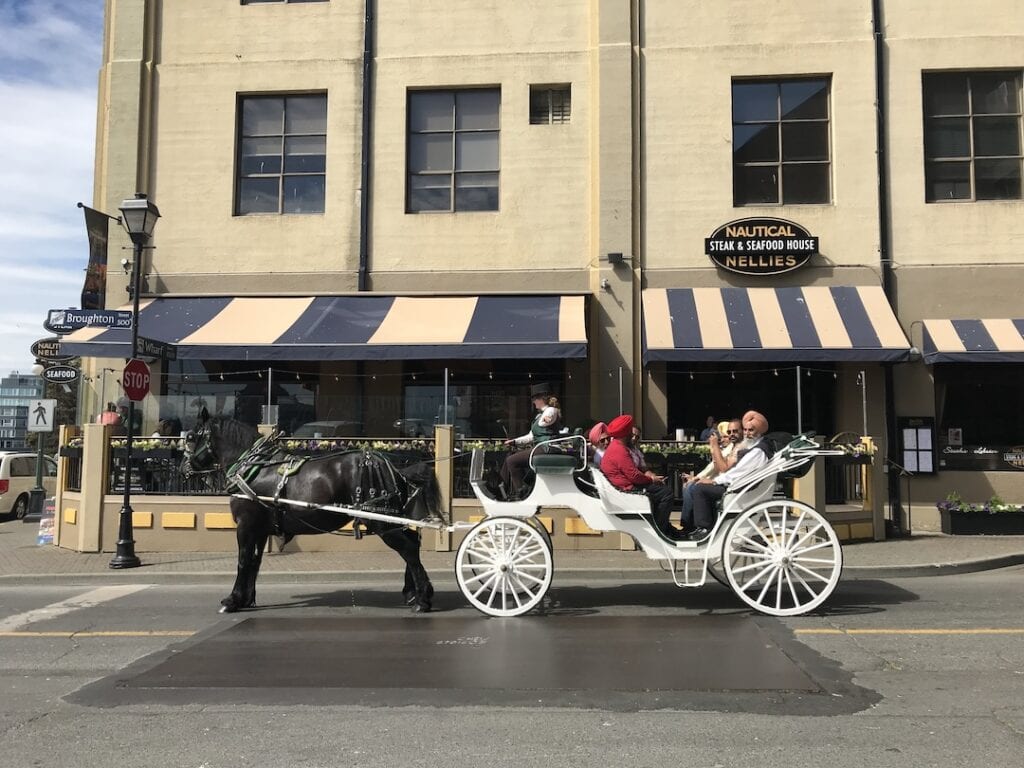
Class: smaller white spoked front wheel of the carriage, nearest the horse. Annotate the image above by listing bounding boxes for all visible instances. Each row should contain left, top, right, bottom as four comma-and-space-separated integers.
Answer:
455, 517, 554, 616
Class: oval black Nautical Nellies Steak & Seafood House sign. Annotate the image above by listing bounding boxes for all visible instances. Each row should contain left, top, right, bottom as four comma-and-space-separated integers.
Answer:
705, 218, 818, 274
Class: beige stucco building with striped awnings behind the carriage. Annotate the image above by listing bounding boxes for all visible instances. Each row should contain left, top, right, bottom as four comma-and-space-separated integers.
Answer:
72, 0, 1024, 528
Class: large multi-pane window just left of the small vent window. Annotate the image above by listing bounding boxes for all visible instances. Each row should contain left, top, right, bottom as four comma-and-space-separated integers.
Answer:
406, 88, 501, 213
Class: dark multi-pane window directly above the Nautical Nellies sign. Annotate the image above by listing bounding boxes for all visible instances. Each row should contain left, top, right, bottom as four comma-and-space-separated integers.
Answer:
732, 78, 831, 207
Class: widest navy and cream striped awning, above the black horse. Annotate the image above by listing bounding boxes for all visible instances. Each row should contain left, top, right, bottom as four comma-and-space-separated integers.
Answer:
60, 295, 587, 360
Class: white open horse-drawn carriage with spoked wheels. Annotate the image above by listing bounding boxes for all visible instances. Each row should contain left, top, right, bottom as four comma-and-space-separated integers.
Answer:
456, 436, 843, 616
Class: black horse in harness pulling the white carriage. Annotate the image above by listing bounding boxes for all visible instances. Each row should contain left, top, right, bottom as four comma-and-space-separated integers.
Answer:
182, 411, 440, 613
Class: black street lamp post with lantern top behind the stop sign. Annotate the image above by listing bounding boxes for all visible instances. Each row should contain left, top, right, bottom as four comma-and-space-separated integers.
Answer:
110, 193, 160, 568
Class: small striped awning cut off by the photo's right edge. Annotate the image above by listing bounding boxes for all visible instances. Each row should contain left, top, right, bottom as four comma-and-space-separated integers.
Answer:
922, 318, 1024, 362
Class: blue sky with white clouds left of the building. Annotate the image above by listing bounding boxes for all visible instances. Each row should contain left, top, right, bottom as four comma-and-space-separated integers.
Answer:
0, 0, 103, 376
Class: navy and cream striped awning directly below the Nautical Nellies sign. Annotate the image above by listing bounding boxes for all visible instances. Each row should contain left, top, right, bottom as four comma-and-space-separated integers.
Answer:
643, 286, 910, 362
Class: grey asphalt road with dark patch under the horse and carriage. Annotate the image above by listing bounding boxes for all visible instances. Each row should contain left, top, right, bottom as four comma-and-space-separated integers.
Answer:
0, 567, 1024, 768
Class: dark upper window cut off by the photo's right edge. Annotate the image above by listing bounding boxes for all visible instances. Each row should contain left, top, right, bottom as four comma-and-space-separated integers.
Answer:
923, 72, 1021, 203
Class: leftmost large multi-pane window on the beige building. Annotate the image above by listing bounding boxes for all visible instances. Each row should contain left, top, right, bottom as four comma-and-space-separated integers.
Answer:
236, 94, 327, 215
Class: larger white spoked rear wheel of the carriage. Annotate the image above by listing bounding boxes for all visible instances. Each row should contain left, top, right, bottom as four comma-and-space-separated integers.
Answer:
722, 499, 843, 616
